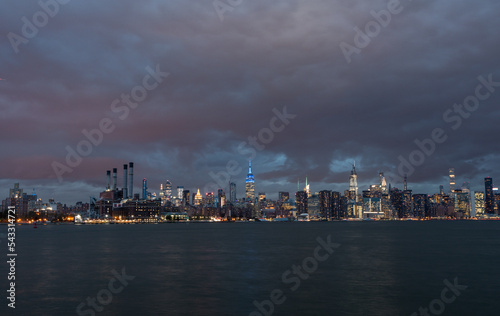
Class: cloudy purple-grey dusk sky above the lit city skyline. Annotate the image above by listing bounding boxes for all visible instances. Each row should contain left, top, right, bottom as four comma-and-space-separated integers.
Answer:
0, 0, 500, 204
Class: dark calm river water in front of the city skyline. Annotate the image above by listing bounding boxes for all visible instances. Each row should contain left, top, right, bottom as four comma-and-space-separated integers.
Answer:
0, 221, 500, 316
